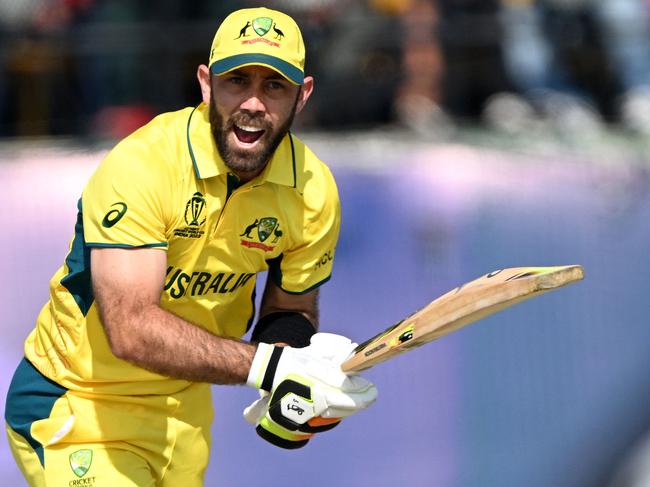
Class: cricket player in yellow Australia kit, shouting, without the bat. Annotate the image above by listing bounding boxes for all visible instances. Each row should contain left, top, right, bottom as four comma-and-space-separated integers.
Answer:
5, 8, 376, 487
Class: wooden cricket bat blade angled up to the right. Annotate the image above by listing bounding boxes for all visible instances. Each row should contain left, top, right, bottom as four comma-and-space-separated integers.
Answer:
341, 265, 584, 373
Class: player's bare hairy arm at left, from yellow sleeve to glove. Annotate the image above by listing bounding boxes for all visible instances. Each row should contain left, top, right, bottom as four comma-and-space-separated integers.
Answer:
91, 248, 256, 384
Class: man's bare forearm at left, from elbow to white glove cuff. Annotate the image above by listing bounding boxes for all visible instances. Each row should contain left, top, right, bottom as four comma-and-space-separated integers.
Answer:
102, 304, 256, 384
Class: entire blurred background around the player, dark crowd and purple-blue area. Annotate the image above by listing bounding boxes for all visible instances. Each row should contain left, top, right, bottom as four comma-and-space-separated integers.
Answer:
0, 0, 650, 487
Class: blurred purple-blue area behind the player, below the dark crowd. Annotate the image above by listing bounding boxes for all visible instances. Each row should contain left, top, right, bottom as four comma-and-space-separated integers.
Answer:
0, 137, 650, 487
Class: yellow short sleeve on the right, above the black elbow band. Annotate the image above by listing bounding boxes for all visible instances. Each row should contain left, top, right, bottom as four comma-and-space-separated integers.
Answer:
269, 168, 341, 294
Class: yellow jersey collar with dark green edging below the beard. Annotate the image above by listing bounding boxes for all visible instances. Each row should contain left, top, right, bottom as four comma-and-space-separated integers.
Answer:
187, 103, 296, 188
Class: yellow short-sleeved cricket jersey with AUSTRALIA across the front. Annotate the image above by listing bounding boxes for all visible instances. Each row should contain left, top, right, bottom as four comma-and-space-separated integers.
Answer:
25, 104, 340, 394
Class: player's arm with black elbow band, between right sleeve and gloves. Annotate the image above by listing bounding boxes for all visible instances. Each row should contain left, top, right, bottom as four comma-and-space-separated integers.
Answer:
251, 279, 318, 348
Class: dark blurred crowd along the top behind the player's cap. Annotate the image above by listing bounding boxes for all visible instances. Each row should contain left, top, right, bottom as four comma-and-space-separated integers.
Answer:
0, 0, 650, 137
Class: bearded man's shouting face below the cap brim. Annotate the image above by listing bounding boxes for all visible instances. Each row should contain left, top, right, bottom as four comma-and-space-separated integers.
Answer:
210, 66, 300, 181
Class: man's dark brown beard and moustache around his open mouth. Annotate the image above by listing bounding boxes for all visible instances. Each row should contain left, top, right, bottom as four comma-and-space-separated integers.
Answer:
210, 92, 298, 175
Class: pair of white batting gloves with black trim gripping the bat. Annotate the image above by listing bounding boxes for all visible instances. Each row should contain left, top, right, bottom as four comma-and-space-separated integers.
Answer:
244, 333, 377, 448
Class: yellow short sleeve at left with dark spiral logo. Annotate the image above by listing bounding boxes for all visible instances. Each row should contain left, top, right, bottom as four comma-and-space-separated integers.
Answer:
82, 128, 167, 248
